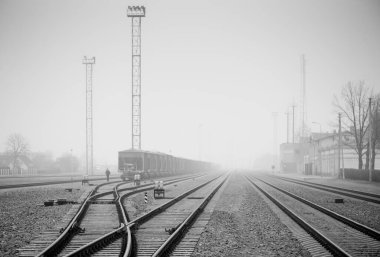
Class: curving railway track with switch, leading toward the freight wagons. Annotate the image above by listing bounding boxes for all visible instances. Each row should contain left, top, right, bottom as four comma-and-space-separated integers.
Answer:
20, 175, 205, 256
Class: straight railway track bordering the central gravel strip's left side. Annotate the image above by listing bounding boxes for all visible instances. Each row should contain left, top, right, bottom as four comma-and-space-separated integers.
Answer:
127, 175, 228, 256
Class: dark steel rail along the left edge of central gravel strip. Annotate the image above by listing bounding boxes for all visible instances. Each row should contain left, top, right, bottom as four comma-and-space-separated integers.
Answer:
152, 174, 229, 257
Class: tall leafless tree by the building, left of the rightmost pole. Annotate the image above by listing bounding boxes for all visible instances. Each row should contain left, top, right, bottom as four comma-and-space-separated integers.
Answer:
334, 81, 371, 170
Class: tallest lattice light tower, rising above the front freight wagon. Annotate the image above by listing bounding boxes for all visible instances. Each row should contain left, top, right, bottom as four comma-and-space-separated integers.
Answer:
127, 6, 145, 150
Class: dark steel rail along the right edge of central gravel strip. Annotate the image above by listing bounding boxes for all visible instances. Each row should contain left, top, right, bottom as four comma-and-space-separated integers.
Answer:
245, 176, 351, 257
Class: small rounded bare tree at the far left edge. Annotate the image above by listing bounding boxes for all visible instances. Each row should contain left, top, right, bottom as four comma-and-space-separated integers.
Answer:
6, 134, 29, 169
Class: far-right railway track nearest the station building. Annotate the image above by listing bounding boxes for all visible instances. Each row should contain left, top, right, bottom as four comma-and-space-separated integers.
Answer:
271, 176, 380, 204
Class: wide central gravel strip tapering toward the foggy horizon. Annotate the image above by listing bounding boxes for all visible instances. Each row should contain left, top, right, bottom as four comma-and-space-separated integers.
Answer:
192, 174, 310, 257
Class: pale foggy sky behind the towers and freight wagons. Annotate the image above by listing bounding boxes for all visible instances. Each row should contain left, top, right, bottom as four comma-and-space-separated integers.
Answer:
0, 0, 380, 168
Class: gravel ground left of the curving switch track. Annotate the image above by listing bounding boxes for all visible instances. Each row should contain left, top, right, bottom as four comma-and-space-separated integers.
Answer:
0, 183, 86, 256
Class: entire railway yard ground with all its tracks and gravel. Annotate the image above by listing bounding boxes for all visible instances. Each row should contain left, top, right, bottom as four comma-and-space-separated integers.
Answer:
0, 172, 380, 256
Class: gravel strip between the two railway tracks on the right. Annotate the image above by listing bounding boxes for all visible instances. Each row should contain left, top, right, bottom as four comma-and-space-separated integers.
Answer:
265, 176, 380, 231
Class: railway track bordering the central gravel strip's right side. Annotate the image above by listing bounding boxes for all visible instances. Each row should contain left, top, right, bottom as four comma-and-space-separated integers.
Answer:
247, 177, 380, 256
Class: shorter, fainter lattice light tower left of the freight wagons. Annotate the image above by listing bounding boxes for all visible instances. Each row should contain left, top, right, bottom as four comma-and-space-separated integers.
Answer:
83, 56, 95, 175
